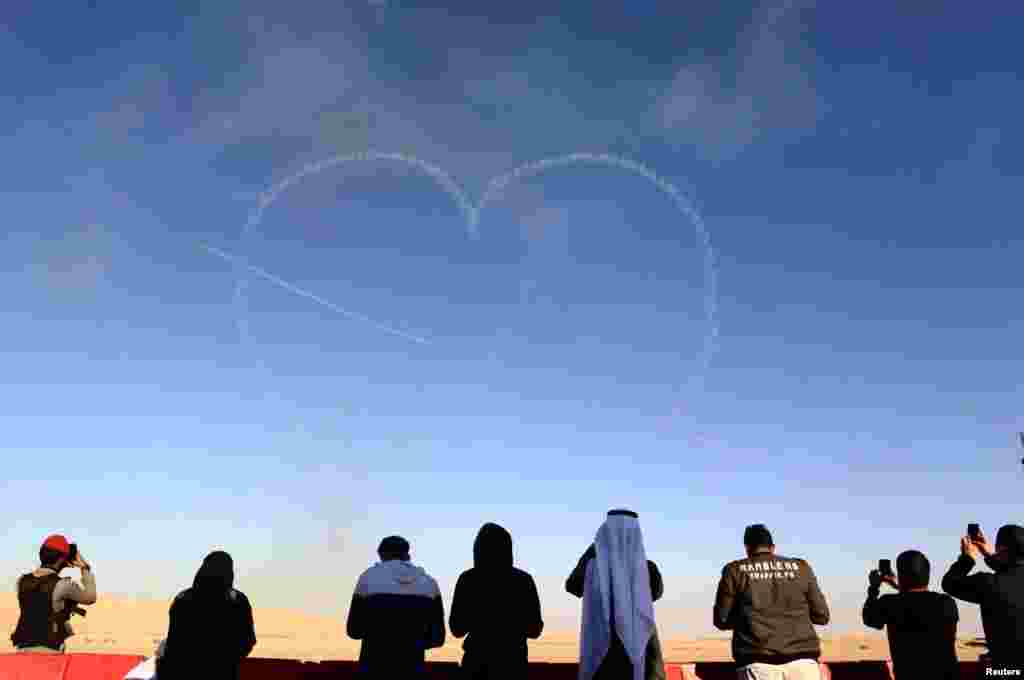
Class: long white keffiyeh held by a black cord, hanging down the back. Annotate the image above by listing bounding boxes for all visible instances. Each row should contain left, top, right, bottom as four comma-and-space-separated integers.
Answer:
580, 515, 654, 680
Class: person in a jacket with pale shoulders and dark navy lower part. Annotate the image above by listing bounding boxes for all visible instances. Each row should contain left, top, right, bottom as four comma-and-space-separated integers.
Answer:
346, 536, 444, 680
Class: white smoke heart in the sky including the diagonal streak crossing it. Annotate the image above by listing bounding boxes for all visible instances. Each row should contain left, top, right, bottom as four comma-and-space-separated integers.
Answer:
220, 152, 719, 371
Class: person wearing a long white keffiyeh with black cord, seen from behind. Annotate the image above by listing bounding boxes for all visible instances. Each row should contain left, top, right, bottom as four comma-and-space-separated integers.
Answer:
565, 510, 666, 680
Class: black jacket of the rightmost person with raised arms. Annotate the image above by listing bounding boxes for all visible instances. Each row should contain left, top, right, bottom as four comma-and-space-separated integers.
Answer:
942, 555, 1024, 669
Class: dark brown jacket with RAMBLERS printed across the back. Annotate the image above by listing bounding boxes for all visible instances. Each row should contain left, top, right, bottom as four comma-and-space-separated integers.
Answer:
713, 553, 828, 666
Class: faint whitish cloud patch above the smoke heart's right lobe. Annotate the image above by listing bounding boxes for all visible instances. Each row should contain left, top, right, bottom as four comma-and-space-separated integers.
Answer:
657, 0, 822, 160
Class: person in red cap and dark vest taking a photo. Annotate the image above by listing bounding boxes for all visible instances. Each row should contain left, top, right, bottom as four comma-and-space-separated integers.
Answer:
10, 535, 96, 653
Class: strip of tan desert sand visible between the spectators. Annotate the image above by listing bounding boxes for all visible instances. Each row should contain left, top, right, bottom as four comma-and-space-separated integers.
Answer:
0, 594, 984, 663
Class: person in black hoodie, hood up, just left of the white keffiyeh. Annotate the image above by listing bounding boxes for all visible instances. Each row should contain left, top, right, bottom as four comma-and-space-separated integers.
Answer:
449, 522, 544, 680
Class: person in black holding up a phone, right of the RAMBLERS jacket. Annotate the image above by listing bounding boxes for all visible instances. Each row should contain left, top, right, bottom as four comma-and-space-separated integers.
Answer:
861, 550, 959, 680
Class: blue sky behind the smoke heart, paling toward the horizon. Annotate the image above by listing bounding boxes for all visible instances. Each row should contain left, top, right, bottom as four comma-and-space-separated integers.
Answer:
0, 1, 1024, 635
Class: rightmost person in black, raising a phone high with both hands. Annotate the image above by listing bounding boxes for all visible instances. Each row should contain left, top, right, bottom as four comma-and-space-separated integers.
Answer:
942, 524, 1024, 671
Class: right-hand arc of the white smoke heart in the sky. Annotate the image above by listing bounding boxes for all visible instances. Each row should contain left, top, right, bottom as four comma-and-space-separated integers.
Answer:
470, 153, 719, 371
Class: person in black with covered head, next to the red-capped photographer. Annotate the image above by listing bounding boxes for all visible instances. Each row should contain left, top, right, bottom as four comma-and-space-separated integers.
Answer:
157, 551, 256, 680
